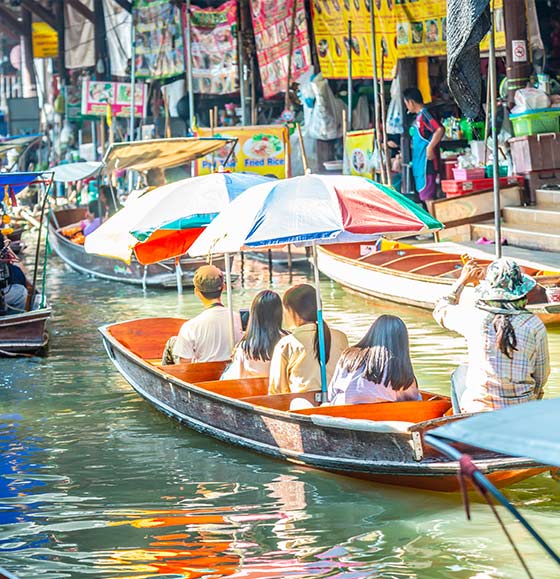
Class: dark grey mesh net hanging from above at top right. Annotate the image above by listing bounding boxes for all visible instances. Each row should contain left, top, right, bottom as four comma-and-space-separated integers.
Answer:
447, 0, 491, 119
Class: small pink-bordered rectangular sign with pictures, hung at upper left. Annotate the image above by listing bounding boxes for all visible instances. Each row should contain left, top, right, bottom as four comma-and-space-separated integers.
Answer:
82, 80, 148, 117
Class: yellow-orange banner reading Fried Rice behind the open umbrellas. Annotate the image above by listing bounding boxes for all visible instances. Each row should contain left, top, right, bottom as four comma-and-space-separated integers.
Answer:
196, 125, 290, 179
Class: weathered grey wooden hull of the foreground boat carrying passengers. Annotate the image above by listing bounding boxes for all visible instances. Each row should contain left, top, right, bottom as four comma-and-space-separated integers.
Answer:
100, 326, 543, 491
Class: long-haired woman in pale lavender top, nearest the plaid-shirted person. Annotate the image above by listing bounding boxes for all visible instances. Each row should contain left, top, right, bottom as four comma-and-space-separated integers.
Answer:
328, 315, 422, 405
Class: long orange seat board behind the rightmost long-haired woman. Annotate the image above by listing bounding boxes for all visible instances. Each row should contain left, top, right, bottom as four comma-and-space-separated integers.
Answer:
293, 400, 451, 422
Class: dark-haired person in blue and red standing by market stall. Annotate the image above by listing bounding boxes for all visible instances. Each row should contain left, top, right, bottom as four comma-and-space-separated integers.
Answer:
403, 88, 445, 202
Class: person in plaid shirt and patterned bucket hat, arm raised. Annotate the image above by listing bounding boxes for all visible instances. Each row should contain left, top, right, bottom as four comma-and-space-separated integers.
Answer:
434, 258, 550, 412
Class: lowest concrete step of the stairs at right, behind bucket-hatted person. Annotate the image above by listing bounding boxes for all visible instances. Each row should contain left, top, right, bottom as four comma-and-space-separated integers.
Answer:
471, 221, 560, 251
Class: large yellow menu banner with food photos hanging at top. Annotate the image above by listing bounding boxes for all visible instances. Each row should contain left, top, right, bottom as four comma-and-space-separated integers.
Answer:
312, 0, 505, 79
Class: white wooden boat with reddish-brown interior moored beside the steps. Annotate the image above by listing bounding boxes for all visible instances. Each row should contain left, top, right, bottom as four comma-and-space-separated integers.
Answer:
318, 243, 560, 324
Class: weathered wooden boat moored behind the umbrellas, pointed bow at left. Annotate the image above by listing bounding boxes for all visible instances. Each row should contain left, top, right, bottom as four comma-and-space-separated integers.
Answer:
49, 208, 225, 288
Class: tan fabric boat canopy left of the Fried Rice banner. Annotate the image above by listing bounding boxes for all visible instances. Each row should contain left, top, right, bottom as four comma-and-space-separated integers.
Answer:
103, 137, 235, 172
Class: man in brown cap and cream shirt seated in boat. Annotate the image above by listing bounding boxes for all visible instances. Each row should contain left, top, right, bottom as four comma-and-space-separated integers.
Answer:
162, 265, 242, 364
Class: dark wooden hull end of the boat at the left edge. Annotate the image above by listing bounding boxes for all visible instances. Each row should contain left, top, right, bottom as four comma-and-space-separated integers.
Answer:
0, 308, 51, 357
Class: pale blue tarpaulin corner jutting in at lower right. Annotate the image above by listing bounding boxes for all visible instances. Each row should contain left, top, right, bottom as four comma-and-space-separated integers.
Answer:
430, 398, 560, 466
